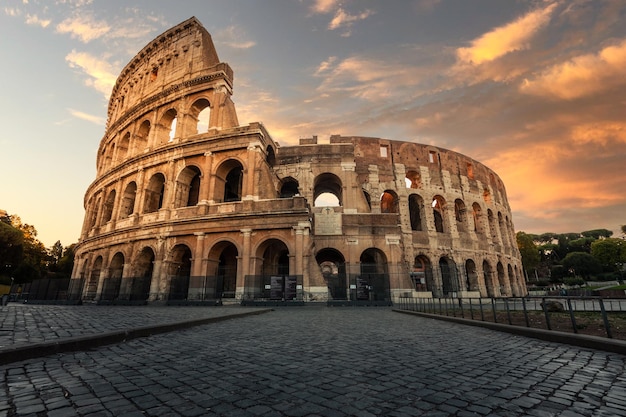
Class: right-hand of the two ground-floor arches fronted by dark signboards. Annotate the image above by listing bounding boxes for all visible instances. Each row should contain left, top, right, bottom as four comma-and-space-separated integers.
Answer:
353, 248, 391, 301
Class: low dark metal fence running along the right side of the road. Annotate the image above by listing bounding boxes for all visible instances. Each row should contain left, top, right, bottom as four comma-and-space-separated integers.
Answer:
396, 296, 626, 339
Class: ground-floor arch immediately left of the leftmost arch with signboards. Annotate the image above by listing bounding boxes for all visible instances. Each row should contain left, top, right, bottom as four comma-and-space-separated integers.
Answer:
208, 241, 239, 298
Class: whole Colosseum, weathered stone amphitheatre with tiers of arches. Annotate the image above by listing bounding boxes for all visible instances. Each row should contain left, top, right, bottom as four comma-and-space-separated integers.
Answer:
71, 17, 526, 305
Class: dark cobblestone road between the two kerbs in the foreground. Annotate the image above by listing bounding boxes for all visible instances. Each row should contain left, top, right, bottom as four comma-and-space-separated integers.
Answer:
0, 307, 626, 417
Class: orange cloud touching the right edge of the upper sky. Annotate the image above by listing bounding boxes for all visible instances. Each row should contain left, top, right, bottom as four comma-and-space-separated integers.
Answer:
520, 40, 626, 100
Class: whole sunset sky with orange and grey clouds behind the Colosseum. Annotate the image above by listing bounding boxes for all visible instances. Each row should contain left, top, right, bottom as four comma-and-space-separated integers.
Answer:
0, 0, 626, 247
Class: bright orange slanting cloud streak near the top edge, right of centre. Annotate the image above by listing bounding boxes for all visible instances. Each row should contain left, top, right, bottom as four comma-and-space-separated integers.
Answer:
456, 3, 556, 65
